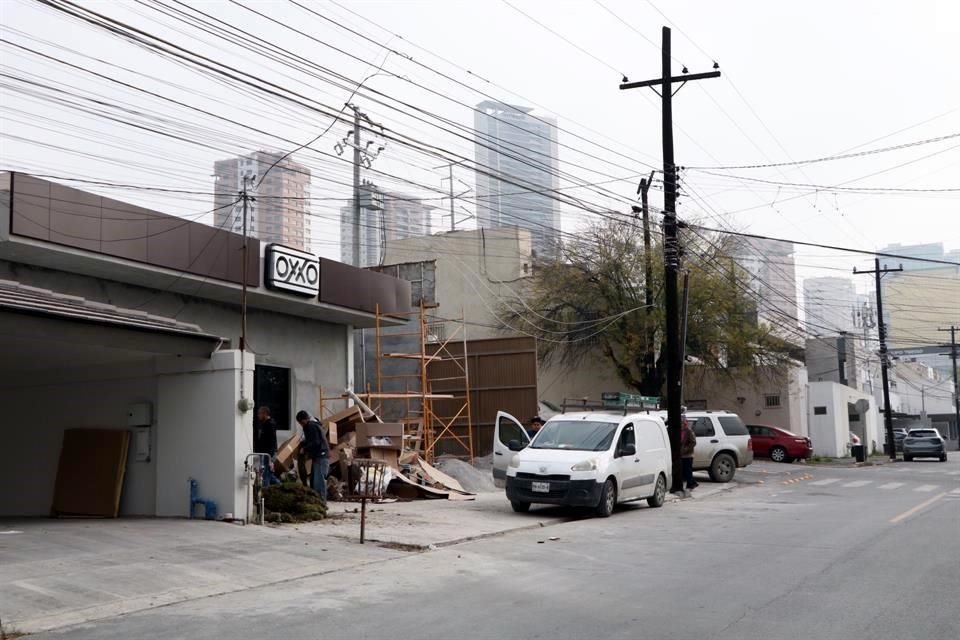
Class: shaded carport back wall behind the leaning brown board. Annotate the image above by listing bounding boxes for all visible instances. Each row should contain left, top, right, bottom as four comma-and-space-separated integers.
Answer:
0, 361, 156, 516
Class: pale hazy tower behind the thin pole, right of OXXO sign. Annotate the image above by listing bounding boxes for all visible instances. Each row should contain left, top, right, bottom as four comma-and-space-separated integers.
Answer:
340, 183, 435, 267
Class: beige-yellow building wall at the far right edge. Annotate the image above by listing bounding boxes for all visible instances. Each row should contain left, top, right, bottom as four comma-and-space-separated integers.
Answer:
883, 267, 960, 348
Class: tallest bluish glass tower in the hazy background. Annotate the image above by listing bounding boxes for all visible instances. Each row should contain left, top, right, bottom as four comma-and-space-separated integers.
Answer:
474, 100, 560, 256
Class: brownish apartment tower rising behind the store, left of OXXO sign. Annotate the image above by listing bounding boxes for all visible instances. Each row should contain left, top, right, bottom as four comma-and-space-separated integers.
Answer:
213, 151, 311, 251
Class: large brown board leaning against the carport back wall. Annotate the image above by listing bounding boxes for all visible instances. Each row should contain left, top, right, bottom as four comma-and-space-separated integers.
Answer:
51, 429, 130, 518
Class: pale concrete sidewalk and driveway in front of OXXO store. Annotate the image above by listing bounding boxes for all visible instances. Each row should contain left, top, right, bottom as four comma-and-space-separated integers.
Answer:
0, 478, 737, 633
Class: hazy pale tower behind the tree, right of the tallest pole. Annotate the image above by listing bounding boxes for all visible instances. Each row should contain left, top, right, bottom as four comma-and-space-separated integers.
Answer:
731, 239, 802, 343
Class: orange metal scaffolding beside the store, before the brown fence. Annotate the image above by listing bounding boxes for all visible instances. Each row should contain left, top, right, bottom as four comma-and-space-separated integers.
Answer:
358, 303, 474, 462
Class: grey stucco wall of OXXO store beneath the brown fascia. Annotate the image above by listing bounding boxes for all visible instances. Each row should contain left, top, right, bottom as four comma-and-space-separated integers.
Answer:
0, 261, 352, 428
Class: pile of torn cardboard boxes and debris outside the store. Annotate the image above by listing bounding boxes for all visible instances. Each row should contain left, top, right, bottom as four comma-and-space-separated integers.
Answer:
274, 406, 474, 502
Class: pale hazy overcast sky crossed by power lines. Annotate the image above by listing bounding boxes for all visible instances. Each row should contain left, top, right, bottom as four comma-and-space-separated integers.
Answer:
0, 0, 960, 289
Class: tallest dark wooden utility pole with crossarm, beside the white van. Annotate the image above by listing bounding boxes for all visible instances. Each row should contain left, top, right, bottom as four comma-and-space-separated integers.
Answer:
620, 27, 720, 492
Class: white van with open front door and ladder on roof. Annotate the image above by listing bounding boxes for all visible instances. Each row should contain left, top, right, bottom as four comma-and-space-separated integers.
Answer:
493, 411, 671, 517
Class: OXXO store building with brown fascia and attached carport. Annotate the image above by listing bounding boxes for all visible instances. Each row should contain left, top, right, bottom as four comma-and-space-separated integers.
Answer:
0, 173, 410, 518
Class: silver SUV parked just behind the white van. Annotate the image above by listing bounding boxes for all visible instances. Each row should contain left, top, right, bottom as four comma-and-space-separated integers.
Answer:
684, 411, 753, 482
